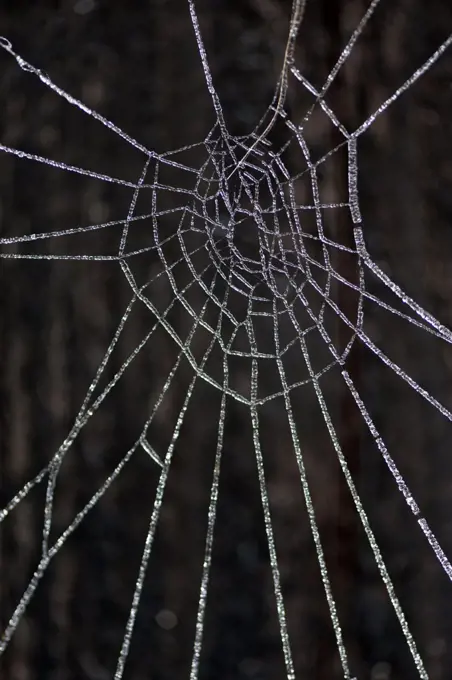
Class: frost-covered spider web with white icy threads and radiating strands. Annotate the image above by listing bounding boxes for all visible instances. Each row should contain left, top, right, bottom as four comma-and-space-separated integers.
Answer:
0, 0, 452, 680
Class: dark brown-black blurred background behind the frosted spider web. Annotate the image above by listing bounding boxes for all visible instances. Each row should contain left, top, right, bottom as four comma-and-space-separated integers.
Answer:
0, 0, 452, 680
